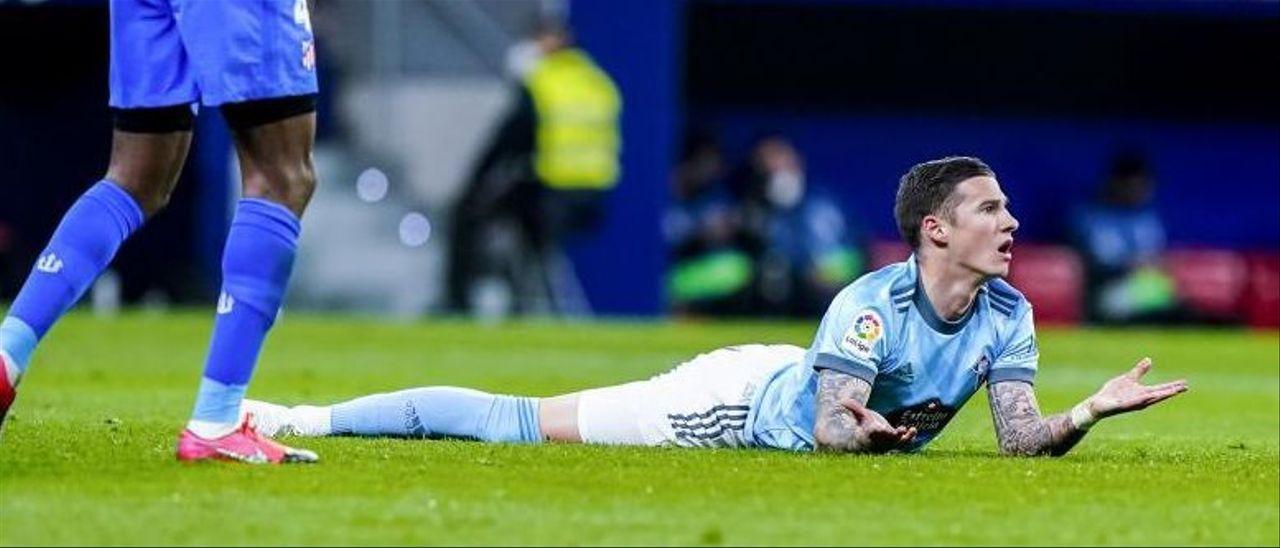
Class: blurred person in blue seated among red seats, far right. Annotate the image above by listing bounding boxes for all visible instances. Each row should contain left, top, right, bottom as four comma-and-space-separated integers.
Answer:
1073, 150, 1178, 323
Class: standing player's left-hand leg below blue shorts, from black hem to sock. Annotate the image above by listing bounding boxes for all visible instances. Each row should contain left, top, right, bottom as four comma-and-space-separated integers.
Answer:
0, 105, 193, 425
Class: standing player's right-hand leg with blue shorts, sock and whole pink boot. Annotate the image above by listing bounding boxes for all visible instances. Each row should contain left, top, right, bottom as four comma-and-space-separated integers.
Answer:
165, 0, 319, 463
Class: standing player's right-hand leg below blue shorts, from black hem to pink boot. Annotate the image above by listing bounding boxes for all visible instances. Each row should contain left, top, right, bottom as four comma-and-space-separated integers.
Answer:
178, 101, 316, 461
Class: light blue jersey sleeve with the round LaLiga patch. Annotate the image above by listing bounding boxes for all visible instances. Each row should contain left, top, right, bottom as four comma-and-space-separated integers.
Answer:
806, 292, 888, 383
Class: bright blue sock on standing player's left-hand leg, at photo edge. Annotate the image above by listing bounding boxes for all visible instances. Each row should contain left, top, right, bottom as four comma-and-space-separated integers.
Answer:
0, 179, 146, 370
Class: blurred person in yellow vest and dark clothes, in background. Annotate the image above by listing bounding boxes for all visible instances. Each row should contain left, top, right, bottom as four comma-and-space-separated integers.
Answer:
447, 23, 622, 312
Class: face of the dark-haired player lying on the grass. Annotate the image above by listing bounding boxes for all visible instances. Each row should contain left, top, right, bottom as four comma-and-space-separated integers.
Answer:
946, 177, 1018, 277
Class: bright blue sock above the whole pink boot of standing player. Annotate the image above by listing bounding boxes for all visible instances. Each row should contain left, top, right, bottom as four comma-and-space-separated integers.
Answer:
191, 198, 301, 425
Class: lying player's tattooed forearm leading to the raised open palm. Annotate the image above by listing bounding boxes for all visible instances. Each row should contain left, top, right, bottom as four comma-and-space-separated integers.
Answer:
988, 382, 1084, 456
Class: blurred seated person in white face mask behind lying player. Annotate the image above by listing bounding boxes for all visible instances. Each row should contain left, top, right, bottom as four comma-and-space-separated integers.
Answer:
733, 134, 865, 315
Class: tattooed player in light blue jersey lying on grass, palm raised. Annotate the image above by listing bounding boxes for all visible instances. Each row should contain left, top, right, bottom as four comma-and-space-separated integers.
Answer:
244, 157, 1187, 456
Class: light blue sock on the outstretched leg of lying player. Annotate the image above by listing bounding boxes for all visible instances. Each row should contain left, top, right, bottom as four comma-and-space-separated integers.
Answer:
330, 387, 543, 443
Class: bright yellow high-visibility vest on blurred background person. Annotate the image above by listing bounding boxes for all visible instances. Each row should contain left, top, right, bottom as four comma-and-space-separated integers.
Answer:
525, 49, 622, 189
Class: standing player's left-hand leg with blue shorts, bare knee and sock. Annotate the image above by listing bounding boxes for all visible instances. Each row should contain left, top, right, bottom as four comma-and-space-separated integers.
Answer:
0, 0, 198, 426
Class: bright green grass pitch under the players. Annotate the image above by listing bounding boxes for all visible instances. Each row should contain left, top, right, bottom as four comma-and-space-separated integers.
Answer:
0, 312, 1280, 545
